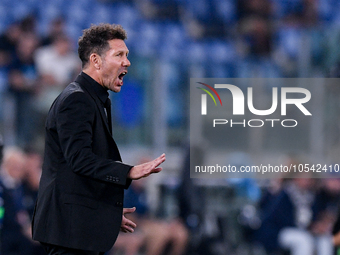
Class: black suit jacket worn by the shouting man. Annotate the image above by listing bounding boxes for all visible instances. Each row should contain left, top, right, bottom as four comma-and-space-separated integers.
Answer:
32, 73, 132, 252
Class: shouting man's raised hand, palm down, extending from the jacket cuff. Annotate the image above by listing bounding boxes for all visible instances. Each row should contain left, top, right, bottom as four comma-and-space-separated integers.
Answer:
128, 153, 165, 180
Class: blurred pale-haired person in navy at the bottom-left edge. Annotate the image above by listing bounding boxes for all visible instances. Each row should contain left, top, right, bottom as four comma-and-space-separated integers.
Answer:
0, 148, 33, 255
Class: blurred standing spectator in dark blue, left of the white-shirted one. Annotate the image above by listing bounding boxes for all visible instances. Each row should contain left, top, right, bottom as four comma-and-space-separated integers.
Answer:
9, 33, 39, 145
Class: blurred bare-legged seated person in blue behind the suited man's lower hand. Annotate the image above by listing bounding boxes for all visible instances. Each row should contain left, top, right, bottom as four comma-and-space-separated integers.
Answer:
114, 177, 188, 255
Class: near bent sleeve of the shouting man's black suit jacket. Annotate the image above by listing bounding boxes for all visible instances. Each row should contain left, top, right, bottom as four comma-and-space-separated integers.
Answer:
56, 92, 132, 187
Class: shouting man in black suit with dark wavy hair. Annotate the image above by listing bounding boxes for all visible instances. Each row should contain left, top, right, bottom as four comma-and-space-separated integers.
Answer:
32, 24, 165, 255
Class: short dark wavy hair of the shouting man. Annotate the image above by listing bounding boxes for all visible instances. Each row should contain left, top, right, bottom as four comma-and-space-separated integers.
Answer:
78, 24, 127, 68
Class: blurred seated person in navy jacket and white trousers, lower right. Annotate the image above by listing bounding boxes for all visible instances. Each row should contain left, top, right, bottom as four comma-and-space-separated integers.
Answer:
256, 178, 332, 255
